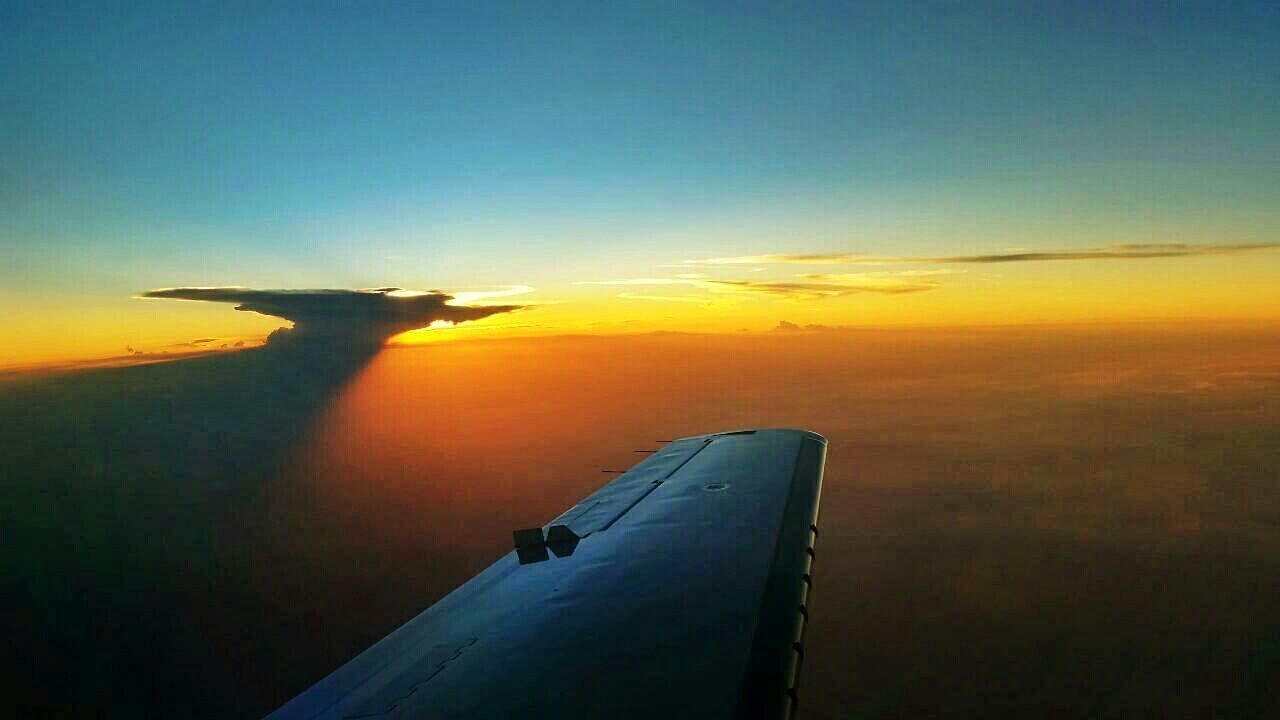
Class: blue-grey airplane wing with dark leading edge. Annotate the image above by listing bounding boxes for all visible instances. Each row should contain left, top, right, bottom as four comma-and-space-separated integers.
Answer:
268, 429, 827, 720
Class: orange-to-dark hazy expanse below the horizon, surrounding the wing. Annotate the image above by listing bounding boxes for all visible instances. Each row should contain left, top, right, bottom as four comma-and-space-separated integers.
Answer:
0, 327, 1280, 717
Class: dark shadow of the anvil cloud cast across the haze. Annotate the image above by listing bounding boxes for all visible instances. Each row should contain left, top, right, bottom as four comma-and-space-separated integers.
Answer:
0, 330, 399, 717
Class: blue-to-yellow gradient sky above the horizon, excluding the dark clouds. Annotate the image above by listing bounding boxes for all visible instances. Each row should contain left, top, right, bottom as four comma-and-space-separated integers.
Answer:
0, 3, 1280, 365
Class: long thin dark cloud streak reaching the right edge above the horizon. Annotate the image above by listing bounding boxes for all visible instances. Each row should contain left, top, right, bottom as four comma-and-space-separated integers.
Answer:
678, 242, 1280, 268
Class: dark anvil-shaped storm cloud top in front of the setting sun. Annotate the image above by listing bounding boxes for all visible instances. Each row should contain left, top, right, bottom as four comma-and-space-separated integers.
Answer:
142, 287, 521, 343
